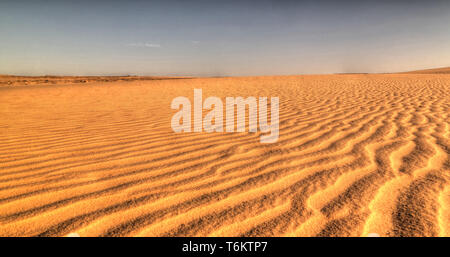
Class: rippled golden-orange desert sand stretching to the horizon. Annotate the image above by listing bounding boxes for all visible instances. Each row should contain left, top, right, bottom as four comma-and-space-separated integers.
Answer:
0, 73, 450, 236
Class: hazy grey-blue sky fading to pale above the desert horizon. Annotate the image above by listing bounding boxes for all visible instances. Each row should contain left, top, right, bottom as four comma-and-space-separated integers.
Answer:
0, 0, 450, 76
